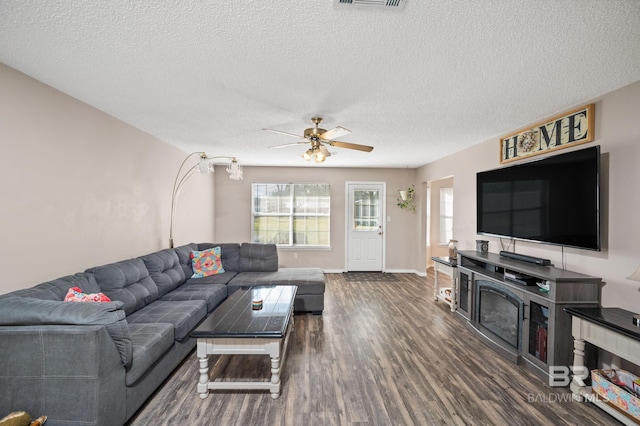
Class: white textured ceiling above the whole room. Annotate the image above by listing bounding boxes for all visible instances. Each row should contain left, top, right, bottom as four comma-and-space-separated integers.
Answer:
0, 0, 640, 167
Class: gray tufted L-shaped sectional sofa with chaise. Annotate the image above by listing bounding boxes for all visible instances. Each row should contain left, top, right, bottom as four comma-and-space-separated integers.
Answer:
0, 243, 325, 426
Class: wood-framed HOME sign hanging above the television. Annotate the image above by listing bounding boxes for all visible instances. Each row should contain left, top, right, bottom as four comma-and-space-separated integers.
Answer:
500, 104, 595, 163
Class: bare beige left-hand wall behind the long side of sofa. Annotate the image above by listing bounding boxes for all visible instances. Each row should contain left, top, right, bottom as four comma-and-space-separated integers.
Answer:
0, 64, 213, 293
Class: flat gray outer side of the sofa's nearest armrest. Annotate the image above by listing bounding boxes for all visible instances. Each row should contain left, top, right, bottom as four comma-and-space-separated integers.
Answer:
0, 325, 127, 425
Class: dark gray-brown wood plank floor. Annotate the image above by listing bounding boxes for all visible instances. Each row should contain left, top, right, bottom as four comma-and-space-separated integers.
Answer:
129, 274, 618, 426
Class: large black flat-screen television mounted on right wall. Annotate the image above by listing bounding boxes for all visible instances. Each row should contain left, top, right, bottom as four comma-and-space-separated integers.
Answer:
476, 146, 600, 250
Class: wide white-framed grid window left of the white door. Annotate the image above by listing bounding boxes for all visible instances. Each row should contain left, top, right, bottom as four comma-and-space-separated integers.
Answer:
251, 183, 331, 247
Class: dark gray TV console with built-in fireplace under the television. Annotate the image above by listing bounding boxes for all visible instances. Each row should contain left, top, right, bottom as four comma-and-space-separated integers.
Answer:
456, 251, 602, 385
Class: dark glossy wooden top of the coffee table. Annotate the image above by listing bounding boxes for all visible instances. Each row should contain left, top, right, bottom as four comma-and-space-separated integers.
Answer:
190, 285, 298, 338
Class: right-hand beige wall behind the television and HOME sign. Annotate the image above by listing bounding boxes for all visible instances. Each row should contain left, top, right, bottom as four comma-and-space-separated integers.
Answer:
417, 82, 640, 312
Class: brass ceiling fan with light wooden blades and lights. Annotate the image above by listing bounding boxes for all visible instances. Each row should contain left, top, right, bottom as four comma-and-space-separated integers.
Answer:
262, 117, 373, 163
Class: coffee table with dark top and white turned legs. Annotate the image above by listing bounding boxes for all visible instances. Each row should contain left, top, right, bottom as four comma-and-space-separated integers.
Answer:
190, 285, 298, 399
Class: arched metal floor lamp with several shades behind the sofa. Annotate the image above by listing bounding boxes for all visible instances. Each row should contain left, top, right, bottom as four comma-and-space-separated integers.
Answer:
169, 152, 242, 248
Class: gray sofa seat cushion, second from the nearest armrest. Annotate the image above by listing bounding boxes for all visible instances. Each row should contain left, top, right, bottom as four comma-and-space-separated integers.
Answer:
127, 300, 207, 340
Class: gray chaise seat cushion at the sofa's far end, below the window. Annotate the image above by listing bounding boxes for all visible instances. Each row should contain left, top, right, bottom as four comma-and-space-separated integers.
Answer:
228, 268, 325, 295
